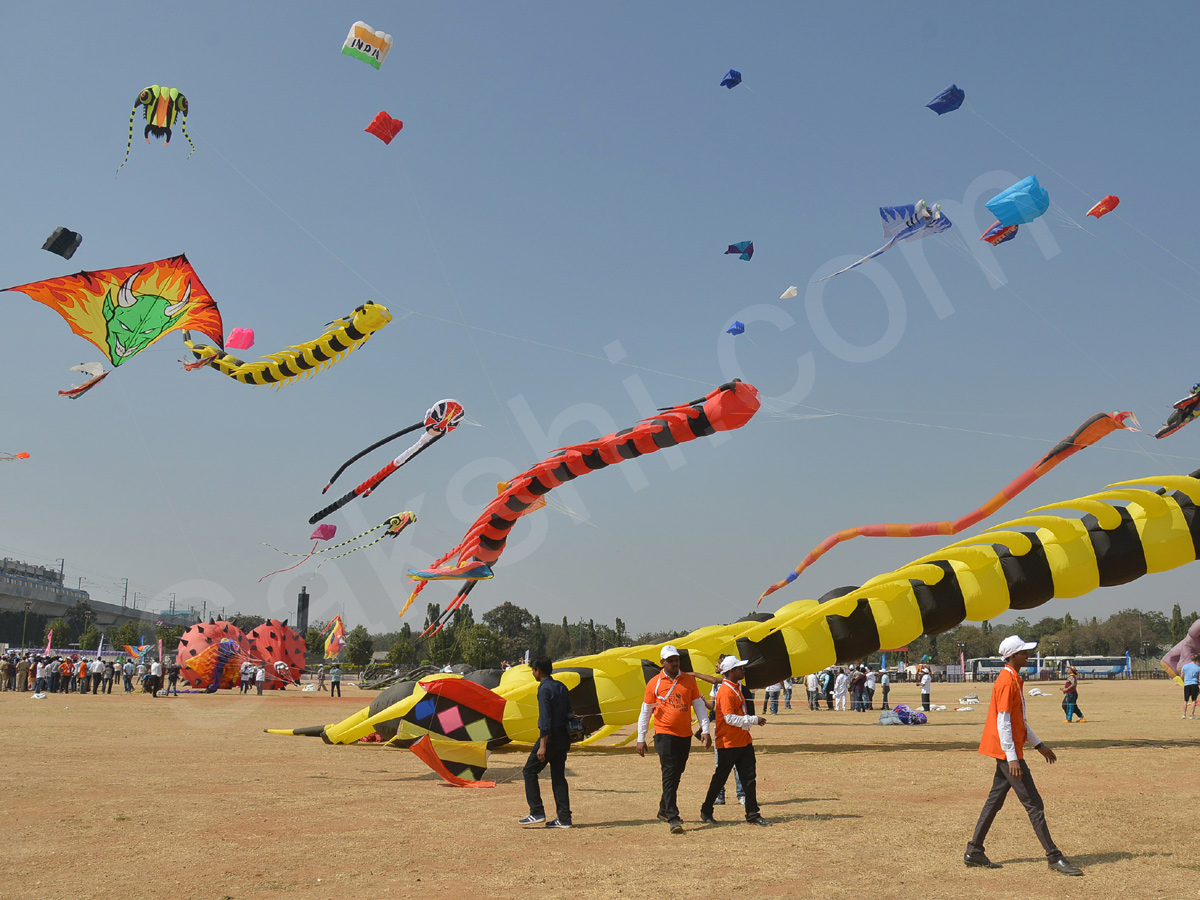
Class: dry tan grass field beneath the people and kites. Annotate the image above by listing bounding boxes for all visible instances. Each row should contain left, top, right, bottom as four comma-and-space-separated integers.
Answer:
0, 682, 1200, 900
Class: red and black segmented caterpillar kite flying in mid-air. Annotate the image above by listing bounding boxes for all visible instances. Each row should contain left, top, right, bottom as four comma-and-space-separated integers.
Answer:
400, 379, 760, 616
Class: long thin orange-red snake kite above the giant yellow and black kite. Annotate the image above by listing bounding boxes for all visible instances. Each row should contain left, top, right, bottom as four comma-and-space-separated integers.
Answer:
758, 410, 1138, 604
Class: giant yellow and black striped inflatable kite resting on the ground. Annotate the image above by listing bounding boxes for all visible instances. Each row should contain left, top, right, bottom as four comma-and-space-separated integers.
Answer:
275, 472, 1200, 778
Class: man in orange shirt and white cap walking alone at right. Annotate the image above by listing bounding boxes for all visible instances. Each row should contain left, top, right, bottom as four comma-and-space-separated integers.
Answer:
962, 635, 1084, 875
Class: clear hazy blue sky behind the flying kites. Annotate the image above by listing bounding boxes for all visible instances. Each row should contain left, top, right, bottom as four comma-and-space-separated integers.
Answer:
0, 2, 1200, 632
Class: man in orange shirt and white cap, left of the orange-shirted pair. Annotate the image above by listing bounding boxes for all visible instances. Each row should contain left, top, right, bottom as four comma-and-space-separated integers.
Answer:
637, 644, 710, 834
